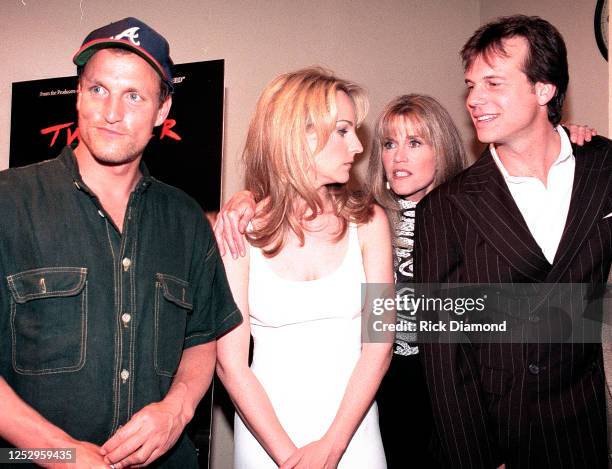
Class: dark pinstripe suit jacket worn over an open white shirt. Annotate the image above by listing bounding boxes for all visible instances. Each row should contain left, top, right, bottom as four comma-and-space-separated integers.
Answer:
415, 133, 612, 469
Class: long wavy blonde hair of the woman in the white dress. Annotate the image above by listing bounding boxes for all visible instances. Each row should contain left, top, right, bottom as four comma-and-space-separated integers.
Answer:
242, 67, 371, 256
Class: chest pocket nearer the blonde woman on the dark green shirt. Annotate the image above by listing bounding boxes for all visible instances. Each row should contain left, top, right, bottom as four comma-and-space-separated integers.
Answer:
154, 274, 193, 376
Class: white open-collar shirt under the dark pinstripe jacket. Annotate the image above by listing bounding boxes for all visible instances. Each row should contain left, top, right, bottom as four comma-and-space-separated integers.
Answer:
489, 126, 576, 264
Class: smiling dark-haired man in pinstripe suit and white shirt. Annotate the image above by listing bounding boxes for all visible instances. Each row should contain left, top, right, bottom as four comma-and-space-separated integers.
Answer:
415, 16, 612, 469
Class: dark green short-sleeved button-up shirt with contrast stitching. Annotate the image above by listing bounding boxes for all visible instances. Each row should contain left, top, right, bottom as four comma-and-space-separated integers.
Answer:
0, 147, 241, 468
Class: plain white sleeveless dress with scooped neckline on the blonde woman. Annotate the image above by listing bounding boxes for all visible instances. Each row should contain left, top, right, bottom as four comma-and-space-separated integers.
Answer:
234, 225, 387, 469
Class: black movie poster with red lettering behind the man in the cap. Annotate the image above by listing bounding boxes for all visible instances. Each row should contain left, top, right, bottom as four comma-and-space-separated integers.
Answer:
9, 60, 224, 211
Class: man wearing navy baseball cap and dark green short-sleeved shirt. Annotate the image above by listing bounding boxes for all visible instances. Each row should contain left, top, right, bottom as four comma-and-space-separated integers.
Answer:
0, 18, 242, 469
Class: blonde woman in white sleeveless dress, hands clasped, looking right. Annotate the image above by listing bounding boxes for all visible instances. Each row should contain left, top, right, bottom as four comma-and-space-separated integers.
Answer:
217, 68, 393, 469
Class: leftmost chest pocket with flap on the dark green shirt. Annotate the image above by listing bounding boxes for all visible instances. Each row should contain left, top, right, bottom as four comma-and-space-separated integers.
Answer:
7, 267, 87, 375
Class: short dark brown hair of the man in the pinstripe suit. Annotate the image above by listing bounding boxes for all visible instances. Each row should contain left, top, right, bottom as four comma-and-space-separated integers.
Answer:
461, 15, 569, 125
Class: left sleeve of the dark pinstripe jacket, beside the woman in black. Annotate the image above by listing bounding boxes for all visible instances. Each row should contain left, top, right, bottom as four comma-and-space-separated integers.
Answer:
414, 190, 503, 469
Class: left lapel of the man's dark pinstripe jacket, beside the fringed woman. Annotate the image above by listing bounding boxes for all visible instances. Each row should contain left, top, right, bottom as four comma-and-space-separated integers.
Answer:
451, 150, 551, 281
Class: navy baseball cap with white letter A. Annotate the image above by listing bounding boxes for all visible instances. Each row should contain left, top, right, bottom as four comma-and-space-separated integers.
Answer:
72, 17, 173, 90
